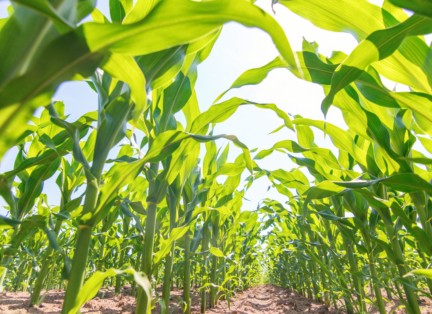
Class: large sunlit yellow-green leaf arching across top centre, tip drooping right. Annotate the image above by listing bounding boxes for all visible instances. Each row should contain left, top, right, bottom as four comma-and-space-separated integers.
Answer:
83, 0, 297, 71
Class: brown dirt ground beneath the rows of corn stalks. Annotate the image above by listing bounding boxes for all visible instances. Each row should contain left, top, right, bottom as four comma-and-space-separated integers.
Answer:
0, 285, 432, 314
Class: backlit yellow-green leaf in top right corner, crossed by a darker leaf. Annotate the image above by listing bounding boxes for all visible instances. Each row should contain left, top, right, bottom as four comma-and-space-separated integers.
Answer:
279, 0, 431, 91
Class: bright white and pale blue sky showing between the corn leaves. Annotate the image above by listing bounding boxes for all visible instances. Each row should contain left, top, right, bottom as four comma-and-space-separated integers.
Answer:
0, 0, 382, 213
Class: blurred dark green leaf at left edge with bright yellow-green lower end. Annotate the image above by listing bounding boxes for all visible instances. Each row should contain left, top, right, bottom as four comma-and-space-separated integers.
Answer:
0, 30, 100, 156
